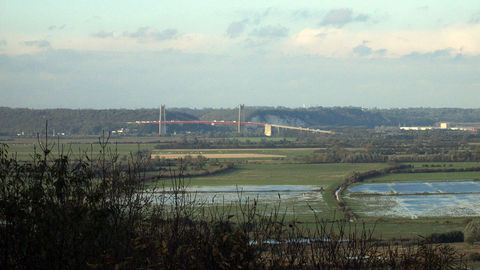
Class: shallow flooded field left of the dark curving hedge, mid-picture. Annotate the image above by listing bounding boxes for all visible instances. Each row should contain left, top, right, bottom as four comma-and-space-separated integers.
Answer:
152, 185, 328, 215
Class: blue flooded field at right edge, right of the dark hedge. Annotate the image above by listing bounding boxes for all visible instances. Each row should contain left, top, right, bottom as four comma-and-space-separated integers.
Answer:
345, 181, 480, 218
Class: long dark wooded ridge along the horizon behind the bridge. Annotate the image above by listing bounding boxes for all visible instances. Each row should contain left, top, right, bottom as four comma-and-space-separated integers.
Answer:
0, 107, 480, 136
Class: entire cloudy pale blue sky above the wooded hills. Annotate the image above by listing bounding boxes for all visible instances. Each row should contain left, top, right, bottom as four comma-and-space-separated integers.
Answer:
0, 0, 480, 109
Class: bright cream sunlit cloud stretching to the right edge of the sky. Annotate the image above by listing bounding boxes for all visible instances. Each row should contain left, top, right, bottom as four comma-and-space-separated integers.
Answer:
284, 24, 480, 58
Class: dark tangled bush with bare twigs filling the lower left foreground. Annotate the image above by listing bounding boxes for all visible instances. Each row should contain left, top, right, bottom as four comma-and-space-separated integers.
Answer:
0, 139, 464, 269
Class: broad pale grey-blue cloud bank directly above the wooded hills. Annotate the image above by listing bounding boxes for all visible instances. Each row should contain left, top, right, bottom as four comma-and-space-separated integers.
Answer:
0, 49, 480, 108
